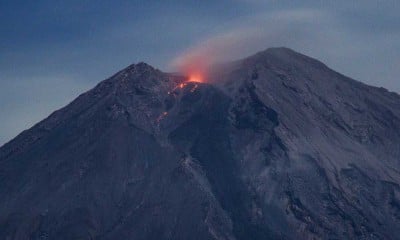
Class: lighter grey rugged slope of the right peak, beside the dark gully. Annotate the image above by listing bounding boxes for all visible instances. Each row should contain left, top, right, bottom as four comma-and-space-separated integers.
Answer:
211, 48, 400, 239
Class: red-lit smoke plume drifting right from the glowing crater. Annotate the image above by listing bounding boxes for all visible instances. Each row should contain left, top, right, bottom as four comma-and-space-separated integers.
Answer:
170, 9, 332, 82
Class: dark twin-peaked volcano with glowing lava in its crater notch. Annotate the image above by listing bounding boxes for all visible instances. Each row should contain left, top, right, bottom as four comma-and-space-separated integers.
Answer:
0, 48, 400, 240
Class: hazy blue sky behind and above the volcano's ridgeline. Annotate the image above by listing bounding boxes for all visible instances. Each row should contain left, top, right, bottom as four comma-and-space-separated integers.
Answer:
0, 0, 400, 145
